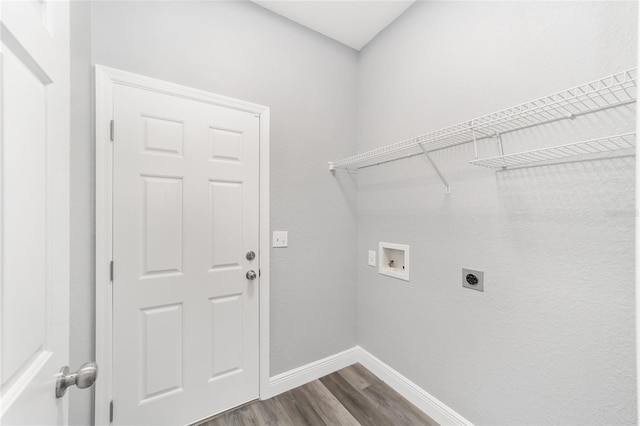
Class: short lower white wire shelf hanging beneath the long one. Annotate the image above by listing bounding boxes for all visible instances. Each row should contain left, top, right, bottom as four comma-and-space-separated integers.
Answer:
469, 133, 636, 169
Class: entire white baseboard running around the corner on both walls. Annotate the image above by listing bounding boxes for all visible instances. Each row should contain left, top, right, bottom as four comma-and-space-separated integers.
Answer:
261, 346, 473, 426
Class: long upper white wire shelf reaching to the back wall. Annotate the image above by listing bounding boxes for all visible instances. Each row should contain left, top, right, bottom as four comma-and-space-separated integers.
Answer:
329, 68, 637, 170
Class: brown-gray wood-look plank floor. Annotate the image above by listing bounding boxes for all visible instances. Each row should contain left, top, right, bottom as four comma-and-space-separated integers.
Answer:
197, 364, 437, 426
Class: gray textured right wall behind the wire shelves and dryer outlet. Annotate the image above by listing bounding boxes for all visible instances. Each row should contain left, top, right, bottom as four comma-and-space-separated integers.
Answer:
358, 2, 638, 425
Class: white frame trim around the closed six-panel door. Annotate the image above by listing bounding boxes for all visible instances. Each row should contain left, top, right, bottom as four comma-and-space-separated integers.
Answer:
94, 65, 270, 425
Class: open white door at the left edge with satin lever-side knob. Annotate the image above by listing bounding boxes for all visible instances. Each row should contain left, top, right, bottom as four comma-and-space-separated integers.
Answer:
0, 0, 69, 425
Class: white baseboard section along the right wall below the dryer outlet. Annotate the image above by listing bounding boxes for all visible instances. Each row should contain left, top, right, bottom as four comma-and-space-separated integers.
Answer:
357, 346, 473, 426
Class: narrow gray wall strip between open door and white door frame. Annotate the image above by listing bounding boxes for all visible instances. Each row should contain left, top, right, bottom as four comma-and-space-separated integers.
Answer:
68, 1, 95, 425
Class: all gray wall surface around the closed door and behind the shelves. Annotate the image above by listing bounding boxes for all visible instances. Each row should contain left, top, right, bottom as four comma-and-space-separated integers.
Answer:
70, 1, 637, 424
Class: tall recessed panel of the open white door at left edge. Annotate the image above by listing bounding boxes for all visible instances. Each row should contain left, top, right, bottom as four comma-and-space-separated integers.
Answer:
2, 43, 47, 386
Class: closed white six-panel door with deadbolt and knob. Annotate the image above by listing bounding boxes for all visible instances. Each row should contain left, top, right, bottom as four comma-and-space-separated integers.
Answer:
113, 85, 259, 425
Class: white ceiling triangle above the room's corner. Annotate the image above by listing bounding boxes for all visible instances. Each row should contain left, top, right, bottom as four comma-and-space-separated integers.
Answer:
252, 0, 415, 50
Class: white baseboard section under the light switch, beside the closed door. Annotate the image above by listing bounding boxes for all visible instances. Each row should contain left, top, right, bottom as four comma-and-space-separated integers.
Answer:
261, 346, 359, 399
